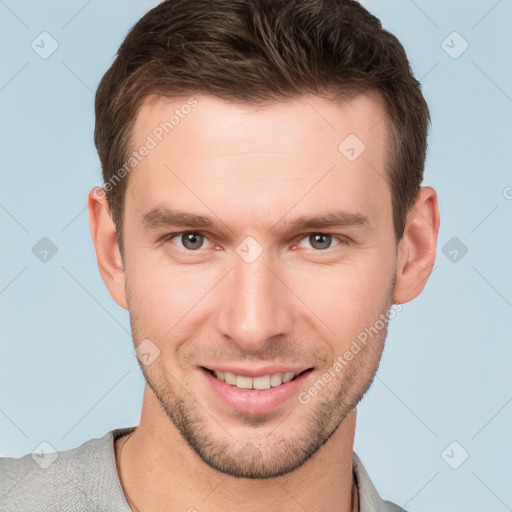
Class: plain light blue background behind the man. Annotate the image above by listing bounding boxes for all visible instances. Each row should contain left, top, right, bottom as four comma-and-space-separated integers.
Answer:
0, 0, 512, 512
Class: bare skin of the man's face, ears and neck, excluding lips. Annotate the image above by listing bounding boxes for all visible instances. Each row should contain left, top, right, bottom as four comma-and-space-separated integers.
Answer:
89, 93, 439, 512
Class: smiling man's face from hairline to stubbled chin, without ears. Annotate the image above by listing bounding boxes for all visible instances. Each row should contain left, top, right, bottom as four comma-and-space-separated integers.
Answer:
119, 95, 397, 478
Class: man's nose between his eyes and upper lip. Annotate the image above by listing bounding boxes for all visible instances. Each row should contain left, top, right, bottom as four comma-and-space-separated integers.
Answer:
217, 244, 296, 352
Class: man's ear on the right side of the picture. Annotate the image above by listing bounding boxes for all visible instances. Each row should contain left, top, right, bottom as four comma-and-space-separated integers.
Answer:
393, 187, 440, 304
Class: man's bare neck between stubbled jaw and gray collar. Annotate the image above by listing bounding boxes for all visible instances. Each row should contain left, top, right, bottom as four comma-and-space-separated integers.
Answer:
115, 388, 357, 512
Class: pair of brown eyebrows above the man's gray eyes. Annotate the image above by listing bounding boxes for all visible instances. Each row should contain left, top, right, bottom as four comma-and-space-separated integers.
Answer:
142, 208, 370, 231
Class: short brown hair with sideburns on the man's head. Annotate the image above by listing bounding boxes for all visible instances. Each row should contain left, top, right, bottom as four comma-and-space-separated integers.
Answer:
94, 0, 430, 249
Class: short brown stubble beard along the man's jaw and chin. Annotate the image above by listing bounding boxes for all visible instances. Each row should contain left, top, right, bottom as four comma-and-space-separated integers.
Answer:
125, 273, 396, 479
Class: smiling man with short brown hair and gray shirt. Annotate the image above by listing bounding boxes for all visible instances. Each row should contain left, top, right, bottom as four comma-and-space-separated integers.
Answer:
2, 0, 439, 512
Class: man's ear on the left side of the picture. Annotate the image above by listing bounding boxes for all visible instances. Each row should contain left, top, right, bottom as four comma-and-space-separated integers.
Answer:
87, 187, 128, 309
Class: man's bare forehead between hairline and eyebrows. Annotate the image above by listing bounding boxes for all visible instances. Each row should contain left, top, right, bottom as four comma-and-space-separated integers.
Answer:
126, 93, 391, 233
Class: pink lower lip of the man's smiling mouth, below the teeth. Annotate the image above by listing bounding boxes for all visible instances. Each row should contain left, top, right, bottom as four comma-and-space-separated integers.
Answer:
201, 368, 312, 415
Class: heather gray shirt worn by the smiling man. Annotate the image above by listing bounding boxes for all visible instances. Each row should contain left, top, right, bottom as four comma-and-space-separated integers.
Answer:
0, 427, 405, 512
